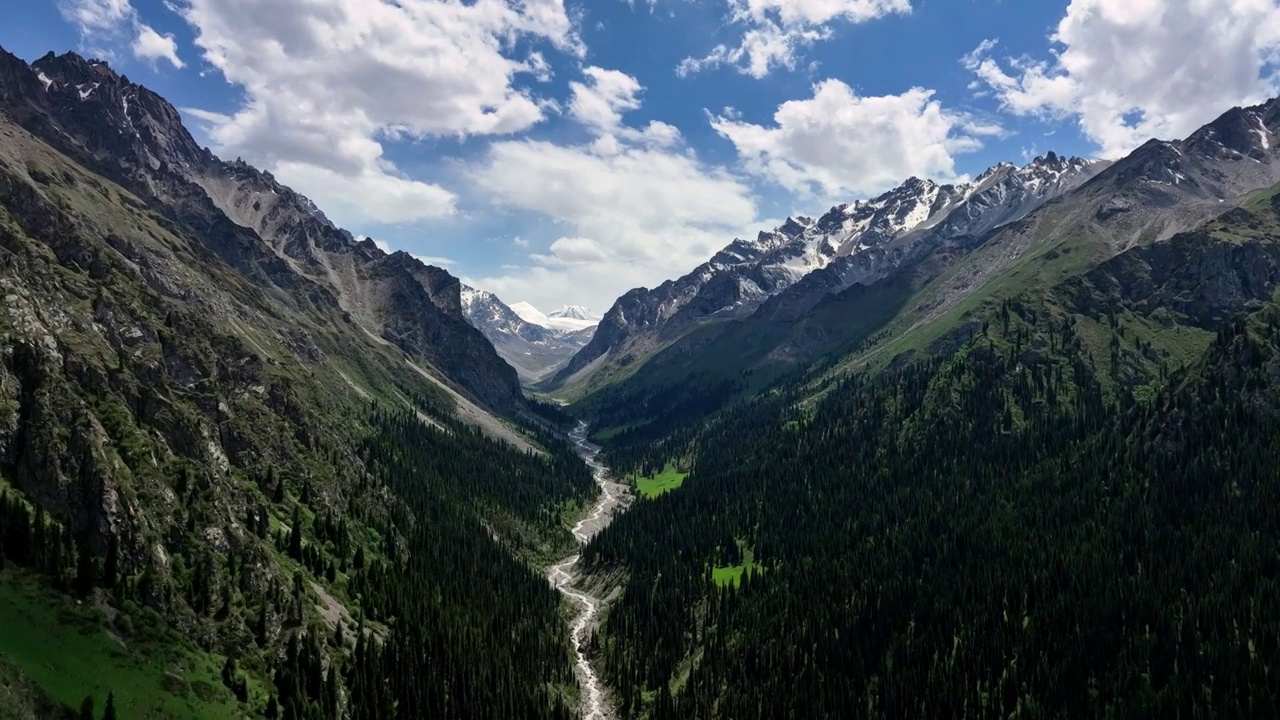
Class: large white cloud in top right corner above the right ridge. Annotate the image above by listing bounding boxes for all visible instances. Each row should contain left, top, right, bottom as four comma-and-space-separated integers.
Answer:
964, 0, 1280, 158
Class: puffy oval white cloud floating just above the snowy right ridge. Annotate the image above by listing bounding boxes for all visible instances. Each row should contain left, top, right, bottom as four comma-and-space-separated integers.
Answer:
712, 79, 1001, 200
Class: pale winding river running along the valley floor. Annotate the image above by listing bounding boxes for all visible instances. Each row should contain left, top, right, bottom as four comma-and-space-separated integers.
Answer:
547, 423, 631, 720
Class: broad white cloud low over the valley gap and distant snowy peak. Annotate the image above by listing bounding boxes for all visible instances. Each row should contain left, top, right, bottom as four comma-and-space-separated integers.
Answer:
471, 136, 759, 307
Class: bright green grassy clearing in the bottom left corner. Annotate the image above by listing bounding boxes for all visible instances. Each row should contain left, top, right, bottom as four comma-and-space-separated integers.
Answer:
0, 568, 262, 720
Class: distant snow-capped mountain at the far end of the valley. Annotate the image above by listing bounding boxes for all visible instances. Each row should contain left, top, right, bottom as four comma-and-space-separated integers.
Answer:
461, 286, 595, 382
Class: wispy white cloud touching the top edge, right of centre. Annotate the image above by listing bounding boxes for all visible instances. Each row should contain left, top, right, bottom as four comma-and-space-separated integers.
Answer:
676, 0, 911, 78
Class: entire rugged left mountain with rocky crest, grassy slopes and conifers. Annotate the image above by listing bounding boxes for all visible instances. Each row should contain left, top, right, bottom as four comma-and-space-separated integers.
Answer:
0, 50, 595, 720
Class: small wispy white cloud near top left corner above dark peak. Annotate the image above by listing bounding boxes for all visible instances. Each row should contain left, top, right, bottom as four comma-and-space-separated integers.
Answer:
58, 0, 184, 68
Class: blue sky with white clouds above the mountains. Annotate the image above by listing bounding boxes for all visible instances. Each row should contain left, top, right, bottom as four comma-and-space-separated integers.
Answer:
0, 0, 1280, 313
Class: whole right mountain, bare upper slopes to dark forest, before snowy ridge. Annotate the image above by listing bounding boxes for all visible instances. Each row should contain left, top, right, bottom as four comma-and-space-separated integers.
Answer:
571, 101, 1280, 720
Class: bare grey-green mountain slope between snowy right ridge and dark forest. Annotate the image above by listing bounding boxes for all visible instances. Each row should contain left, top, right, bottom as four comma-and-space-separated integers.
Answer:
576, 101, 1280, 448
